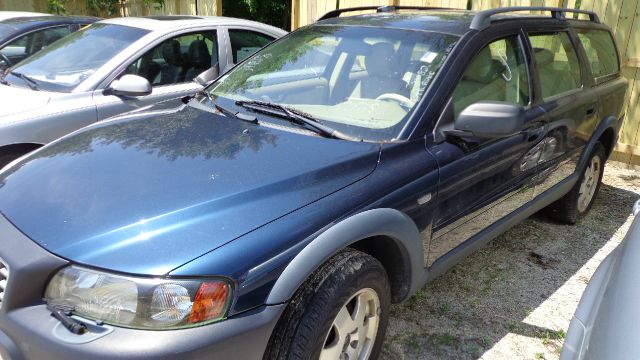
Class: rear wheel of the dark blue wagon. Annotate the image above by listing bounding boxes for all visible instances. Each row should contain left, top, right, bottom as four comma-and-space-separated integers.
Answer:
547, 142, 607, 224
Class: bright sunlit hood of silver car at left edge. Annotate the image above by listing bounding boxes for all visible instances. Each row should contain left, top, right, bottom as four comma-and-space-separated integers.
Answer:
0, 85, 52, 119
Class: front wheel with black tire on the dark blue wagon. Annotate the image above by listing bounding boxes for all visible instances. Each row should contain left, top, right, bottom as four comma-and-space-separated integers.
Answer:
264, 248, 391, 360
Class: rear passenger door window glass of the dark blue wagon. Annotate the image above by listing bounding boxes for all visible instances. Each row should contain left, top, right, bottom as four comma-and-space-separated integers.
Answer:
529, 32, 582, 100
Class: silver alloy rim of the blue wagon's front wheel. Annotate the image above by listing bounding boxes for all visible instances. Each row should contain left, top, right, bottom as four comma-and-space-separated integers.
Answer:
320, 288, 380, 360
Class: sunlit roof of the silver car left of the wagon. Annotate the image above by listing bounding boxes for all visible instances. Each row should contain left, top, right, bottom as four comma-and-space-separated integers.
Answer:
100, 16, 284, 32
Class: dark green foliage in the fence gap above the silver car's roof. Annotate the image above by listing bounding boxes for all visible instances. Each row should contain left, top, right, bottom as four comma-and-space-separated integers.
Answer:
222, 0, 291, 30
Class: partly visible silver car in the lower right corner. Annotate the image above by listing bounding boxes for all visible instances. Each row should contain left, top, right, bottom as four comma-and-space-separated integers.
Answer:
560, 200, 640, 360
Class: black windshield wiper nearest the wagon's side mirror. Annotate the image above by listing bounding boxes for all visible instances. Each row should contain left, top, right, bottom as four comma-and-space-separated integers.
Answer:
236, 100, 362, 141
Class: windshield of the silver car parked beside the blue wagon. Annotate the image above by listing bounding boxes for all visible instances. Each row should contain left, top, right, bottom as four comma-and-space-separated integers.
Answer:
5, 23, 148, 92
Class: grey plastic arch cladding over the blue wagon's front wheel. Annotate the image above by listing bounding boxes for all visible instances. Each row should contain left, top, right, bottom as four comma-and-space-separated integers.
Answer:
266, 208, 424, 304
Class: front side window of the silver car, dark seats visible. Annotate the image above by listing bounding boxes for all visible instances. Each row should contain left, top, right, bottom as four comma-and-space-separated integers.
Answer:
125, 31, 218, 86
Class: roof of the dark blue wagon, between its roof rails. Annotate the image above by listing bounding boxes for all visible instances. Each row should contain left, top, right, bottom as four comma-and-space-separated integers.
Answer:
315, 9, 604, 36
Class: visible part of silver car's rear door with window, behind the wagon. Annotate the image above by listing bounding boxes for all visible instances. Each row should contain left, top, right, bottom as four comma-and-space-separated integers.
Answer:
221, 27, 276, 72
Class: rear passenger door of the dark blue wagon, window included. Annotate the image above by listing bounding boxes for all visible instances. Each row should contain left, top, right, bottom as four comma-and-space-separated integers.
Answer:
528, 29, 598, 196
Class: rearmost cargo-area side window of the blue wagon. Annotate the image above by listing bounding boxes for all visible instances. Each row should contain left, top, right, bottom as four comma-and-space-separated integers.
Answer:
578, 29, 620, 80
